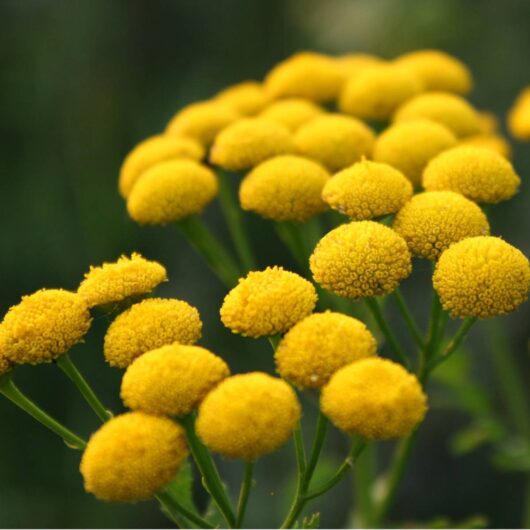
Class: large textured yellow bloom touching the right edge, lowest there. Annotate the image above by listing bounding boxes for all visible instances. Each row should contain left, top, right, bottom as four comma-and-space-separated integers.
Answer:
433, 236, 530, 318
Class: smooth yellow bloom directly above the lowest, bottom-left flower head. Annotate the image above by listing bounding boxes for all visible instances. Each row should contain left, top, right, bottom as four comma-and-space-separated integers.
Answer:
121, 344, 230, 416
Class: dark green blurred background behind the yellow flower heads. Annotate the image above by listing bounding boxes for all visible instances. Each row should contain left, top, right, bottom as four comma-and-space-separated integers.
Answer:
0, 0, 530, 528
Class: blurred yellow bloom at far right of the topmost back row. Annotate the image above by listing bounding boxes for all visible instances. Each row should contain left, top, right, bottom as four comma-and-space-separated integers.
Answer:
395, 50, 473, 94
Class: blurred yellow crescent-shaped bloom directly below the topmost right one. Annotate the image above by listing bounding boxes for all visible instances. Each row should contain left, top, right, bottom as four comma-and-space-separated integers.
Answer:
393, 92, 481, 138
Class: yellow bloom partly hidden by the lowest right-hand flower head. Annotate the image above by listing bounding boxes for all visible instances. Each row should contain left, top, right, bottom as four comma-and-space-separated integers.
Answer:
275, 311, 377, 388
